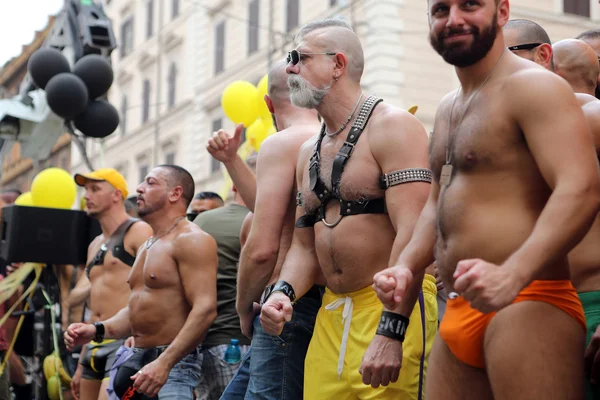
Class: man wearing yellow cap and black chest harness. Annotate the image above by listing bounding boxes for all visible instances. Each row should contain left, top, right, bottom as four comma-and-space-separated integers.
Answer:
69, 168, 152, 399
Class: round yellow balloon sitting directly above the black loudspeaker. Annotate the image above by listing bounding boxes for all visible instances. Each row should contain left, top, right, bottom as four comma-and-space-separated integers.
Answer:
31, 168, 77, 209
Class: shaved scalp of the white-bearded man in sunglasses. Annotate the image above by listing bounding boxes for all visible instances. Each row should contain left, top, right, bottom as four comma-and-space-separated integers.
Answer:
294, 19, 365, 82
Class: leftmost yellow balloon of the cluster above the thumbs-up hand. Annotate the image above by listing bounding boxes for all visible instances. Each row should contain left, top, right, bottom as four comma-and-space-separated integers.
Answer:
221, 81, 258, 127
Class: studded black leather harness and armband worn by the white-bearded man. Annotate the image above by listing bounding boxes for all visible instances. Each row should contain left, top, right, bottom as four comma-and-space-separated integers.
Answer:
296, 96, 432, 228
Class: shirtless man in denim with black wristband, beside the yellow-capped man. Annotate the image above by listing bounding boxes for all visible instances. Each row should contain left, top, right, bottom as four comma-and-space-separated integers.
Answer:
65, 165, 217, 400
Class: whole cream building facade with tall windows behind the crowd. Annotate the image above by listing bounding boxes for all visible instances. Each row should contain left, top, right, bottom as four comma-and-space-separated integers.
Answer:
73, 0, 600, 199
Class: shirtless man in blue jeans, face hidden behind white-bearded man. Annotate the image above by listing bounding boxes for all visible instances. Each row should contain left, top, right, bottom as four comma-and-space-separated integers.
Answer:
208, 60, 321, 400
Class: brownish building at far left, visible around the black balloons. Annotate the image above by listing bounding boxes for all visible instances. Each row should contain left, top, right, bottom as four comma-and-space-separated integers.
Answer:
0, 17, 71, 192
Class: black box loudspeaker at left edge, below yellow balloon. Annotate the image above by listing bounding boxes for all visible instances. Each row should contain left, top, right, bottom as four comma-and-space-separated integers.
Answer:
0, 205, 101, 265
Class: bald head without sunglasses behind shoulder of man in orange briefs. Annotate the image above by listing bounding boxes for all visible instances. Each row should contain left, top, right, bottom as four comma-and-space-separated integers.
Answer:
552, 39, 600, 94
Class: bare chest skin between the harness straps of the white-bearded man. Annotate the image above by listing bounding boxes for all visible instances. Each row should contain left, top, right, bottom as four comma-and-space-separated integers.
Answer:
301, 131, 383, 212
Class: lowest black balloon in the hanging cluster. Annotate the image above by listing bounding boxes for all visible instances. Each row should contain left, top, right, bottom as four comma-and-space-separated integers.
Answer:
75, 100, 119, 138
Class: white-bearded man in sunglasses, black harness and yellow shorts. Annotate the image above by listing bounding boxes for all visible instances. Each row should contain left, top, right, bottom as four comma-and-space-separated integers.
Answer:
261, 19, 437, 399
